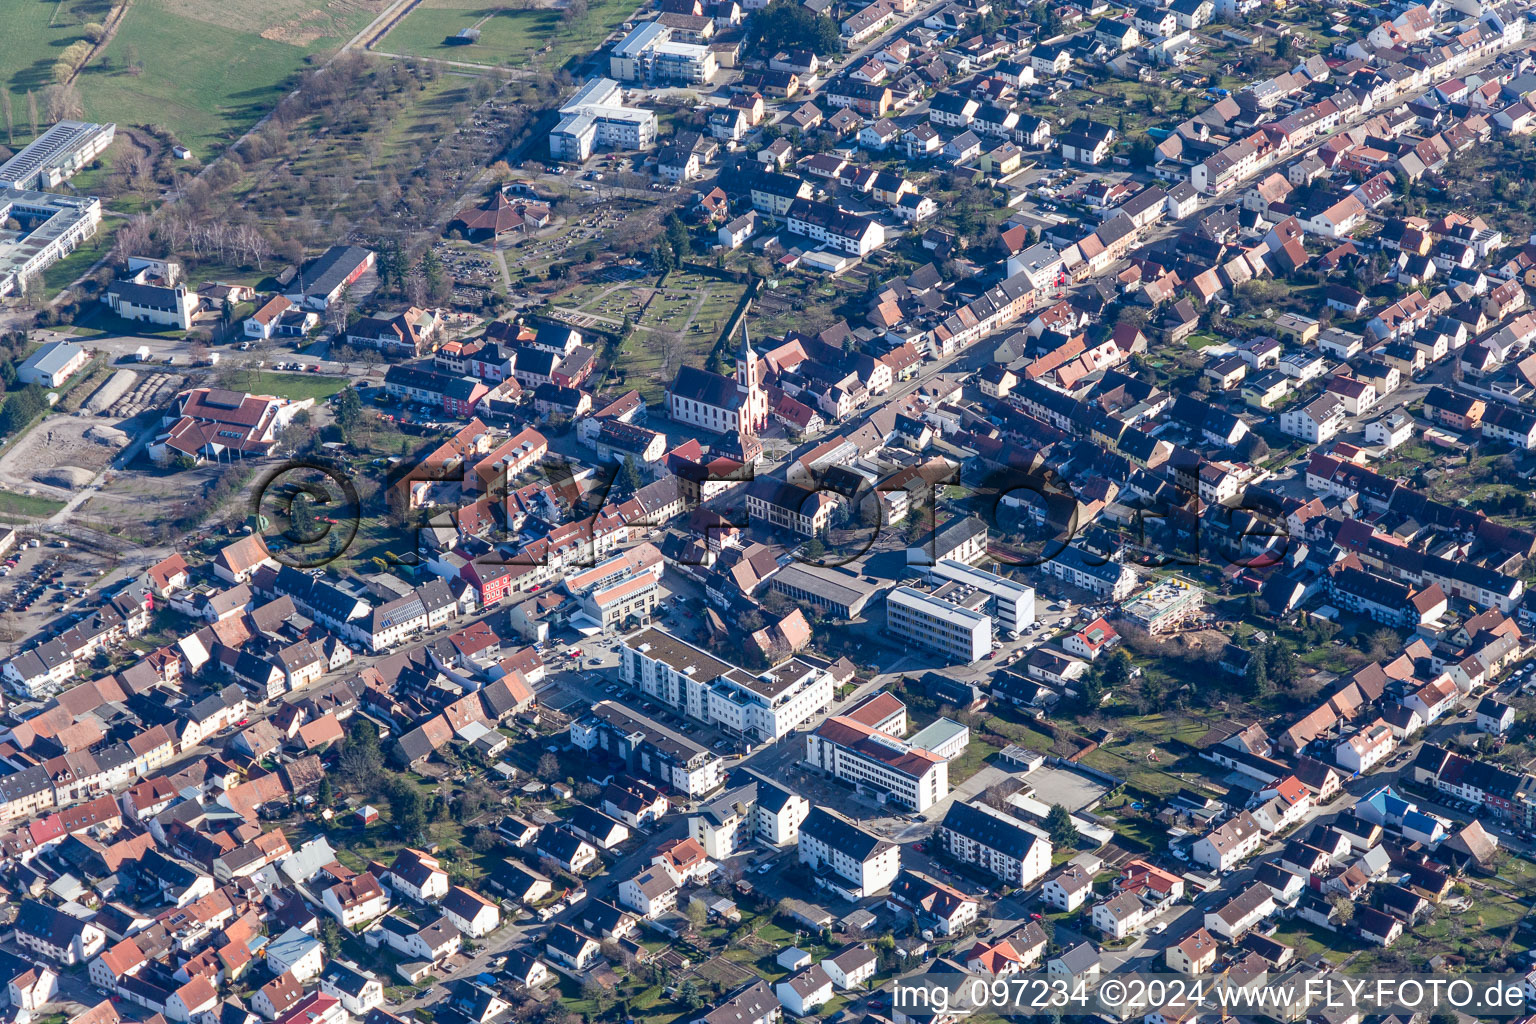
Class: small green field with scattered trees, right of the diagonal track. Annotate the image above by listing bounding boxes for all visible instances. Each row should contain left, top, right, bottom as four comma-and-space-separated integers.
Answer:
378, 0, 639, 71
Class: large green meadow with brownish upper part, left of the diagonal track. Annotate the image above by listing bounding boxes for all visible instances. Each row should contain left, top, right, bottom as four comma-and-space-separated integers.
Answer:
78, 0, 382, 161
